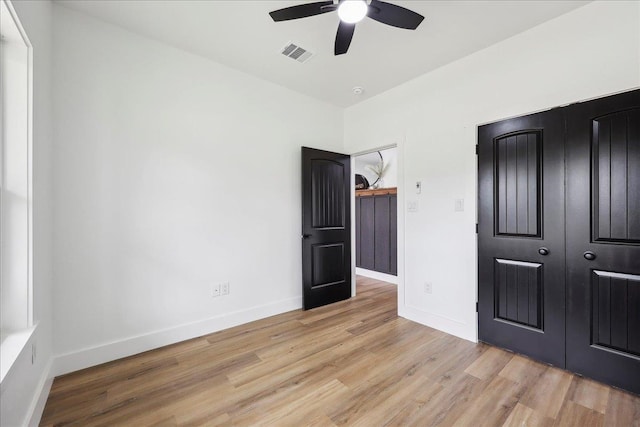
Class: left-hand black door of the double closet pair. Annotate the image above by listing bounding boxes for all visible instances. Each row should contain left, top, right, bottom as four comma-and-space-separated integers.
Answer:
478, 110, 565, 367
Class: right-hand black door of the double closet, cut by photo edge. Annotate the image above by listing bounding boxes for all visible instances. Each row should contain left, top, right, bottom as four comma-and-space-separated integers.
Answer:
567, 90, 640, 393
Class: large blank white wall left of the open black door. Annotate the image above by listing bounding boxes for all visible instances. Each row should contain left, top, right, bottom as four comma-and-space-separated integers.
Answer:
53, 5, 343, 374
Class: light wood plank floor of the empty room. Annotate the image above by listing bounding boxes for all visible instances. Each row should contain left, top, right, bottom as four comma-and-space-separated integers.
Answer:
42, 278, 640, 427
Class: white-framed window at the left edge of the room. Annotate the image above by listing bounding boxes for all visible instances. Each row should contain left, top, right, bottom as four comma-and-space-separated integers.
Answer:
0, 0, 33, 381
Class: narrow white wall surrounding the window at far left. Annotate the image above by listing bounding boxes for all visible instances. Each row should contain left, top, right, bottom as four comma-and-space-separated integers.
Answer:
0, 1, 53, 427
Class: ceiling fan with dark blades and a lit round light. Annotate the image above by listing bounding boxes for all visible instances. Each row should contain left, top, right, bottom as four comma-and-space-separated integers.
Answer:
269, 0, 424, 55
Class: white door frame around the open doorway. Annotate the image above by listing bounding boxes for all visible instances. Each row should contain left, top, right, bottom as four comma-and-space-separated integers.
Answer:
349, 140, 405, 304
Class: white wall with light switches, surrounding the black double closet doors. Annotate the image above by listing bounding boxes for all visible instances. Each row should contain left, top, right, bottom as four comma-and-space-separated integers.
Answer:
345, 2, 640, 340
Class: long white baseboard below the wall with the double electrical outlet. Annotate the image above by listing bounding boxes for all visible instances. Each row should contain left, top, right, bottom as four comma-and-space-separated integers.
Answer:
53, 297, 302, 376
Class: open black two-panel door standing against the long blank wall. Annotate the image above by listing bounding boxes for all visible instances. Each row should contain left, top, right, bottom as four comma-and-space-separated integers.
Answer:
302, 147, 351, 310
